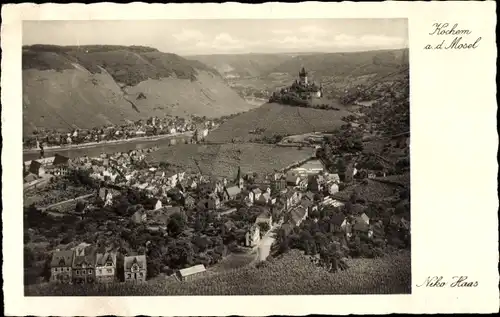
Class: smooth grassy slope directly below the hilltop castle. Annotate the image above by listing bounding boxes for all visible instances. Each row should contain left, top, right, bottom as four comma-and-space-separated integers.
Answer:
207, 103, 349, 142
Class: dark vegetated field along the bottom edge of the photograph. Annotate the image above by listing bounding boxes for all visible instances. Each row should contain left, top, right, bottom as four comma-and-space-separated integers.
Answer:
25, 251, 411, 296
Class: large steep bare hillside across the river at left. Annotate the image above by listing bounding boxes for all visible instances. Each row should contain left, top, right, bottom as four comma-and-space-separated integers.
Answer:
23, 45, 252, 133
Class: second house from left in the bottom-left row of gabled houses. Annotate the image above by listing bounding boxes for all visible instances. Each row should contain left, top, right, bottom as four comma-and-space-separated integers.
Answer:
72, 246, 96, 284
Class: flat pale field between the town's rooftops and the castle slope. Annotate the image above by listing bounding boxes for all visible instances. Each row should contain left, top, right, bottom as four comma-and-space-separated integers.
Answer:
146, 143, 314, 179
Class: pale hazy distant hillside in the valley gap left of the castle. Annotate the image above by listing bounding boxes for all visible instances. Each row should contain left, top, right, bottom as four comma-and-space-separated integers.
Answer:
187, 54, 292, 78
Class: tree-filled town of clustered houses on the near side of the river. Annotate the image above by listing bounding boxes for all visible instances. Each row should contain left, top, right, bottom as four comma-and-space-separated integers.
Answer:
23, 105, 410, 283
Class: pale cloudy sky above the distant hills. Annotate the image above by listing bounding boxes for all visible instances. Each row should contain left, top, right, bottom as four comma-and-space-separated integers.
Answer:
23, 19, 408, 56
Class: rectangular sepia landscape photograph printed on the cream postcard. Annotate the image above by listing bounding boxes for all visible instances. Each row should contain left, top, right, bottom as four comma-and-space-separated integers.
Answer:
21, 18, 408, 297
